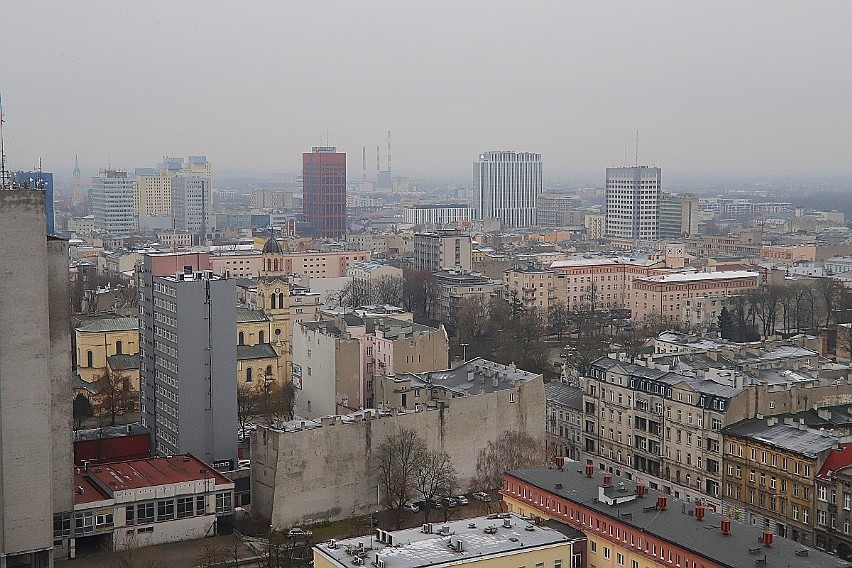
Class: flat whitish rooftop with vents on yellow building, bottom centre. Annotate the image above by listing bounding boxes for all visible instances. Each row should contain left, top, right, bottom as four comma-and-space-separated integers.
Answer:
314, 513, 585, 568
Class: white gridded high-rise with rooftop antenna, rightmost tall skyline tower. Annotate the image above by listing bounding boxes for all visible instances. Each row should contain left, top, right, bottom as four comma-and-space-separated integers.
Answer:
606, 166, 660, 241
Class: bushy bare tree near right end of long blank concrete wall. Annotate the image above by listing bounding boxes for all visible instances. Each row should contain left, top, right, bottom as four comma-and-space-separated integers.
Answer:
476, 430, 545, 492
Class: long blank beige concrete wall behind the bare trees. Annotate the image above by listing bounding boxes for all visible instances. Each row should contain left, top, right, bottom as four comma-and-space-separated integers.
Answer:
252, 378, 546, 527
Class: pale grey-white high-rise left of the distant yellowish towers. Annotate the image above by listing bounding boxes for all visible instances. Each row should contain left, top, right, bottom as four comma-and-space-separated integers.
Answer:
92, 170, 136, 237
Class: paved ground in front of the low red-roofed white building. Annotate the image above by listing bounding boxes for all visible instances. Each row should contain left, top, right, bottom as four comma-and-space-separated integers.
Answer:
55, 536, 254, 568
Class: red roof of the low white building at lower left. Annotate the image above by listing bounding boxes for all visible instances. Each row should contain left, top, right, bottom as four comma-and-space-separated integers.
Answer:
86, 454, 233, 491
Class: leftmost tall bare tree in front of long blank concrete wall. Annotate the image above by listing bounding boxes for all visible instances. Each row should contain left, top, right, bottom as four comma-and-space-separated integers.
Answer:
375, 428, 426, 528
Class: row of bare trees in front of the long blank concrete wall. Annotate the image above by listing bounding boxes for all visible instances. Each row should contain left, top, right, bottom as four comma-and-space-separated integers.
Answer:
375, 428, 545, 528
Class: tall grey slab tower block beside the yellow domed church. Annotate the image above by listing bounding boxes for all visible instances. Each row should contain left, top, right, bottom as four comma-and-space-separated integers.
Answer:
139, 254, 238, 469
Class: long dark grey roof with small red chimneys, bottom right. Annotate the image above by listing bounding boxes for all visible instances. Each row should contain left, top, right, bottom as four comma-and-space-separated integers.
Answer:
507, 462, 852, 568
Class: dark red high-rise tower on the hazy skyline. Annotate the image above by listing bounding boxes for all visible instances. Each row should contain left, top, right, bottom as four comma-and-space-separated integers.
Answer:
302, 146, 346, 239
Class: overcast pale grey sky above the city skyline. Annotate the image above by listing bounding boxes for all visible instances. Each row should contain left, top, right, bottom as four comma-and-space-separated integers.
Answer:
0, 0, 852, 179
